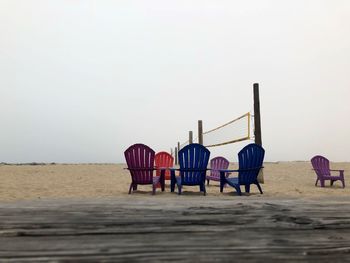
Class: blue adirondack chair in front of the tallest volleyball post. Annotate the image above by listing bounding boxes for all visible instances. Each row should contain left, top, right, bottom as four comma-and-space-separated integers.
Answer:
220, 143, 265, 195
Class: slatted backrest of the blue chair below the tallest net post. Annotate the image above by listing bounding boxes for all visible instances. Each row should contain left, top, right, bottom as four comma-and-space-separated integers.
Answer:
238, 143, 265, 185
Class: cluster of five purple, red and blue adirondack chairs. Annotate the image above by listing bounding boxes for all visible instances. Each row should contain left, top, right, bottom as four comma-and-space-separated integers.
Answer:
124, 143, 265, 195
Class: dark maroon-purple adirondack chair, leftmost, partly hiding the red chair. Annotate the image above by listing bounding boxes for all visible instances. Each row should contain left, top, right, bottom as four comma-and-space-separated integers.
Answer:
124, 143, 165, 194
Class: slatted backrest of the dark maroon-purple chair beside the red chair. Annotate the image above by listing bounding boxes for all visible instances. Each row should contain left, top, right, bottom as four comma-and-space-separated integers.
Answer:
124, 143, 155, 183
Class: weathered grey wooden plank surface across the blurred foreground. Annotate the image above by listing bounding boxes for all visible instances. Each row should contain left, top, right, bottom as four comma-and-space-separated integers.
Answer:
0, 197, 350, 262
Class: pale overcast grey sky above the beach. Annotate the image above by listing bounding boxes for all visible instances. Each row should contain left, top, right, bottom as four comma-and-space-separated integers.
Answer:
0, 0, 350, 163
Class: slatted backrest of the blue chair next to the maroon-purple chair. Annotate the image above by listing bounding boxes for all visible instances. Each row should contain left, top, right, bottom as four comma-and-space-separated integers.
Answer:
179, 143, 210, 185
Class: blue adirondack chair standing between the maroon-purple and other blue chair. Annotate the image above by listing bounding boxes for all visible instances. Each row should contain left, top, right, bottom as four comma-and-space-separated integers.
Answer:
170, 143, 210, 195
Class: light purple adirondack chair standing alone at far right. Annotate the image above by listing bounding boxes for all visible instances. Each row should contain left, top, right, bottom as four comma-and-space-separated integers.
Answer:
311, 155, 345, 188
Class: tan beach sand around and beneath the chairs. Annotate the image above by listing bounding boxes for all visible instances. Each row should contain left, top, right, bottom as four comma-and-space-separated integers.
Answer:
0, 162, 350, 202
